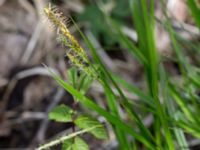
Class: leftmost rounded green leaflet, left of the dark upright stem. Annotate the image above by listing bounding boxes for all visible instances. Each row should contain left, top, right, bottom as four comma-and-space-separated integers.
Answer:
49, 104, 74, 122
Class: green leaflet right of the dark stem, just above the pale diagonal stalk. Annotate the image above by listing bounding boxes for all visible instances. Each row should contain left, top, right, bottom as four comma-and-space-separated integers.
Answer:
75, 115, 107, 139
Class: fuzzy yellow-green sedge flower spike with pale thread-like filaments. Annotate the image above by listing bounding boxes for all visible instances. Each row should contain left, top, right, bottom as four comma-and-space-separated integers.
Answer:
44, 5, 96, 78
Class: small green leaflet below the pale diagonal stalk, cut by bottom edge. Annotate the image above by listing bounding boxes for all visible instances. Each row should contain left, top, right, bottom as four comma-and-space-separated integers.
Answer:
73, 137, 89, 150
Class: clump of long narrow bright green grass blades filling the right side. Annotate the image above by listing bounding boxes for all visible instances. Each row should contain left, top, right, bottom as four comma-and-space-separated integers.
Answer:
44, 0, 200, 150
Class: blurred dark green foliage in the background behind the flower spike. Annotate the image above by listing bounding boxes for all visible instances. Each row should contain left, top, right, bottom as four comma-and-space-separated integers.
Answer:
77, 0, 130, 46
